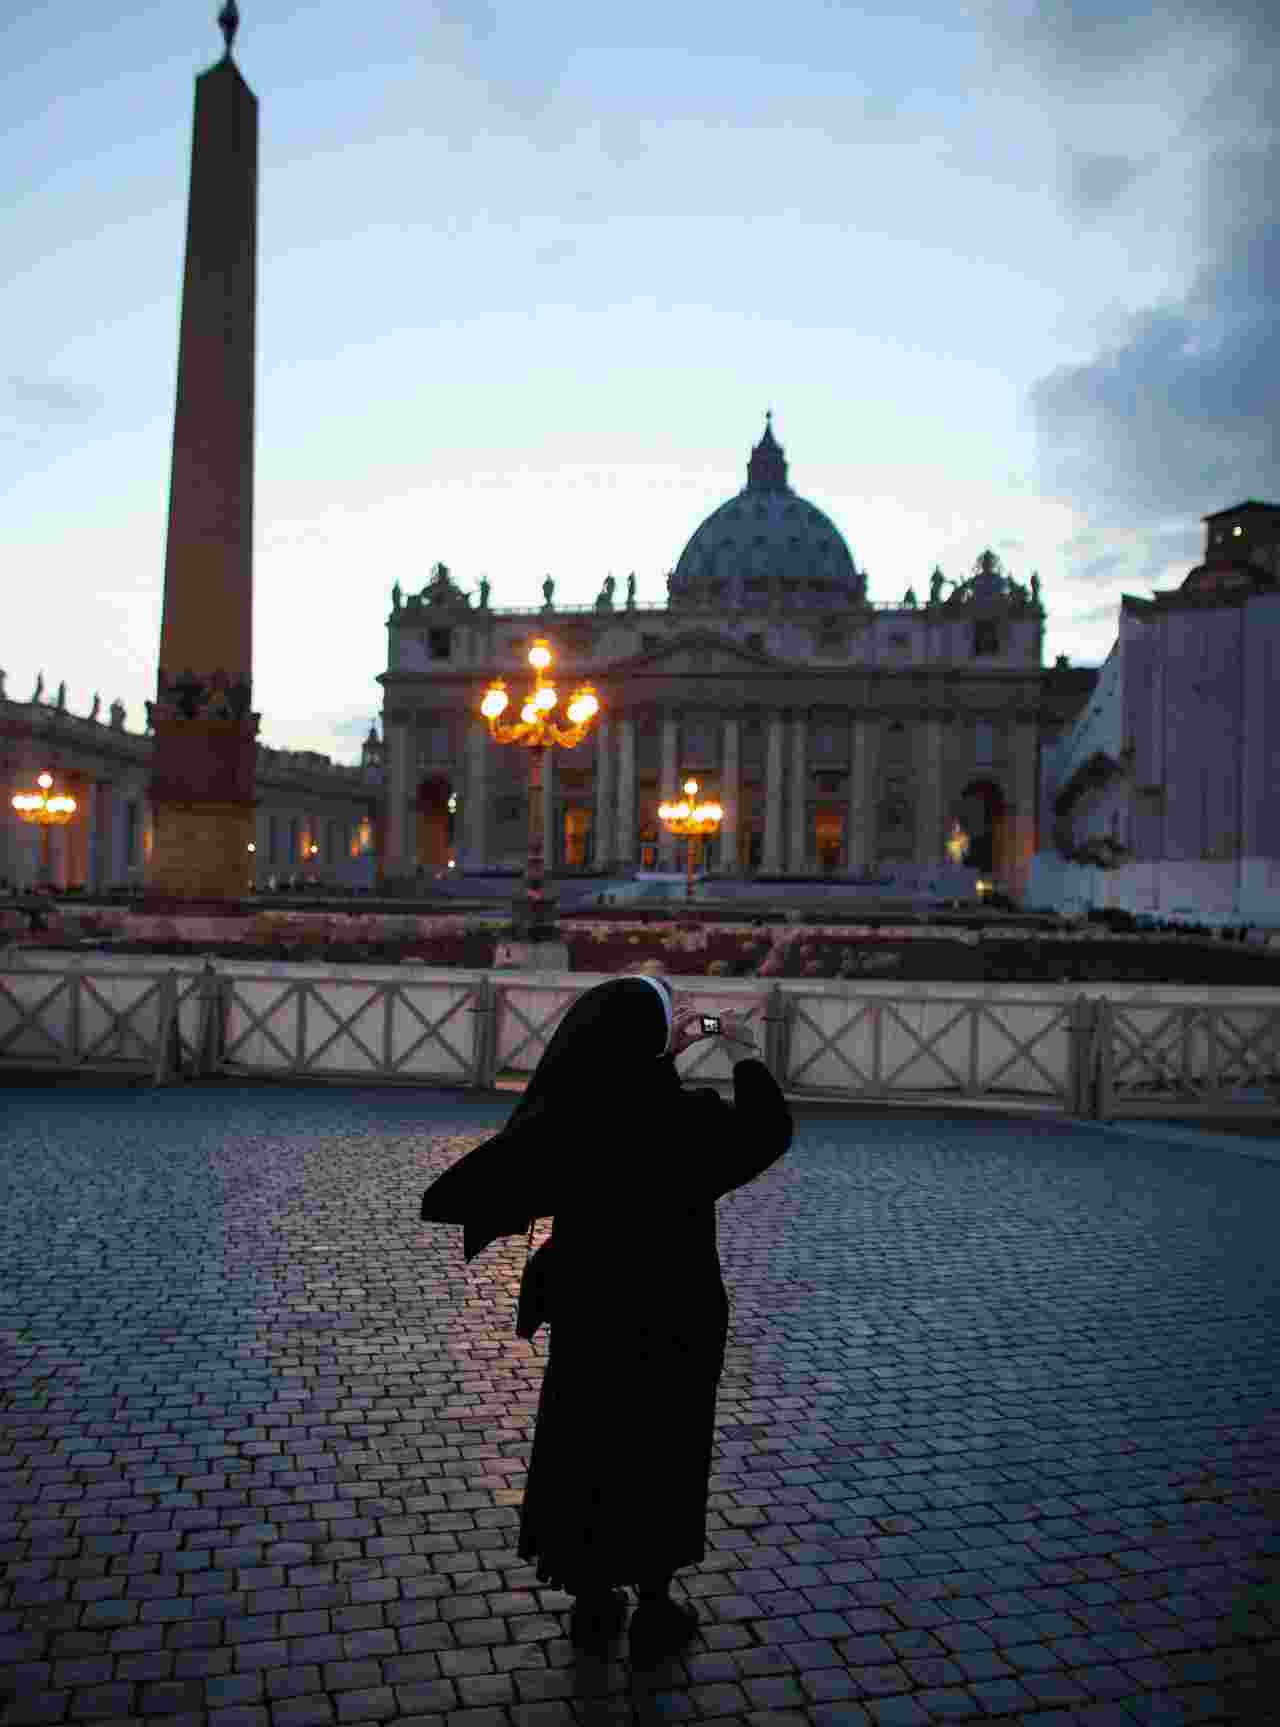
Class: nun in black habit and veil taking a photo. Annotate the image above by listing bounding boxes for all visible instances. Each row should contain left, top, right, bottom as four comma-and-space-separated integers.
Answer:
421, 976, 791, 1663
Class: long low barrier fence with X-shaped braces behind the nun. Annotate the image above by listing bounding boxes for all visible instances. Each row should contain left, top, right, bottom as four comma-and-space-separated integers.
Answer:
0, 960, 1280, 1121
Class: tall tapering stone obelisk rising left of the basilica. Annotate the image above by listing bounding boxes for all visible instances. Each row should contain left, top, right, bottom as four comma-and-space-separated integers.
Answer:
147, 0, 257, 910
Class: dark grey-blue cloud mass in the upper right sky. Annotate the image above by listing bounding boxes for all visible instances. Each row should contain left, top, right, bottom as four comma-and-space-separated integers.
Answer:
993, 0, 1280, 525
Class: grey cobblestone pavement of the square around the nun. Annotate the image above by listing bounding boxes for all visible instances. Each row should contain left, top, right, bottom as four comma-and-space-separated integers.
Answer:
0, 1085, 1280, 1727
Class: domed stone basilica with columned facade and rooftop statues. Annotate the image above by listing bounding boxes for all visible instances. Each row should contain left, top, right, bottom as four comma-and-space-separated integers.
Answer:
380, 423, 1097, 895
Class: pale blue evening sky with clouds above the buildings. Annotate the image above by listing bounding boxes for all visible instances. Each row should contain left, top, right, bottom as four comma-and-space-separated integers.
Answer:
0, 0, 1280, 762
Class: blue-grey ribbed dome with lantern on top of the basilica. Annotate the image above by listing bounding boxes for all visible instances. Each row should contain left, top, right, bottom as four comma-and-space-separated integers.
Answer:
667, 414, 865, 611
